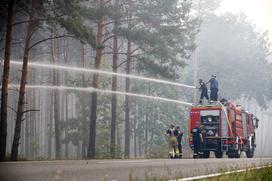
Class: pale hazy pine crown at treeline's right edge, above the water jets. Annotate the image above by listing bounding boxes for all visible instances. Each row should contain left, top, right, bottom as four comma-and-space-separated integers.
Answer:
115, 0, 198, 79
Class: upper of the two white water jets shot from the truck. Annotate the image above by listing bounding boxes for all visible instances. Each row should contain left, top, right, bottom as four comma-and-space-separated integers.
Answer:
10, 60, 196, 89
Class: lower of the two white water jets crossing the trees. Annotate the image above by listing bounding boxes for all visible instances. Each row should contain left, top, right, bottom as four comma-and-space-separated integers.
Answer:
9, 84, 193, 106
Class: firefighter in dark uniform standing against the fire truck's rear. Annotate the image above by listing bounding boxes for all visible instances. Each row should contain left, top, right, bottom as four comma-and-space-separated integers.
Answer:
191, 126, 203, 158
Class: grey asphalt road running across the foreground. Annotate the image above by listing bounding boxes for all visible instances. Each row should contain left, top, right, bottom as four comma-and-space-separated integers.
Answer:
0, 157, 272, 181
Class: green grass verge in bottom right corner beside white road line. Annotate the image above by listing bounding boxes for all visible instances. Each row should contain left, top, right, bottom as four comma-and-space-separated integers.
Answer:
199, 166, 272, 181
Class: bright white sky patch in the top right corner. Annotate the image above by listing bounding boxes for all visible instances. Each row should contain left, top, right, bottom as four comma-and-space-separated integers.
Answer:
218, 0, 272, 42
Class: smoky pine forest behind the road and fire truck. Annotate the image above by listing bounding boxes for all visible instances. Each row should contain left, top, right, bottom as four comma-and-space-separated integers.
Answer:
0, 0, 272, 161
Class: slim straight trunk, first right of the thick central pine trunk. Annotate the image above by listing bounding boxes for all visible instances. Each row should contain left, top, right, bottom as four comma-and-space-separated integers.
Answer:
110, 0, 119, 158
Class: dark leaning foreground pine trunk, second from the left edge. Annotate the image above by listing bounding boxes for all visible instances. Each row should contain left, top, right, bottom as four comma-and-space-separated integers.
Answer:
10, 0, 35, 161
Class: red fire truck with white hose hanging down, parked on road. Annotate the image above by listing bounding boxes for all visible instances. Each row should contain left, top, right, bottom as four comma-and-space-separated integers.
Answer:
189, 100, 259, 158
